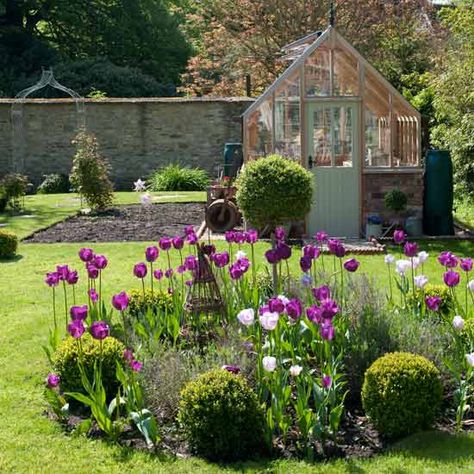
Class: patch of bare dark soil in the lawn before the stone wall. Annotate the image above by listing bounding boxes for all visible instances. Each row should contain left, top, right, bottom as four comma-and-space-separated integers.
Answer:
24, 203, 205, 243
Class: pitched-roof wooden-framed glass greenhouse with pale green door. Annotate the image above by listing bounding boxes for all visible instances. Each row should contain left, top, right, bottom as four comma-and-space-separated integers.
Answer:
243, 26, 423, 237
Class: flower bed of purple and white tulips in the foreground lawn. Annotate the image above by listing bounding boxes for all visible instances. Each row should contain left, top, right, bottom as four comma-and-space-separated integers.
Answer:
41, 226, 474, 460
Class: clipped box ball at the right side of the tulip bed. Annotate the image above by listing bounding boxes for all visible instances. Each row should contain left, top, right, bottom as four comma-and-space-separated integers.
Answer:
362, 352, 443, 438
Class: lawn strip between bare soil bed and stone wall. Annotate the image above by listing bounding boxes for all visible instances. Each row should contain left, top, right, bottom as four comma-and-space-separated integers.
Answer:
0, 191, 206, 239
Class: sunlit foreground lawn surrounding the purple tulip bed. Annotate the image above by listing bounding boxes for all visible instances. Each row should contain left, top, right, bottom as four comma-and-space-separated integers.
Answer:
0, 243, 474, 474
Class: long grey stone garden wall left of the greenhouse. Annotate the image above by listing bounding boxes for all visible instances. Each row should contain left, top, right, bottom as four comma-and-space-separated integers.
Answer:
0, 98, 252, 189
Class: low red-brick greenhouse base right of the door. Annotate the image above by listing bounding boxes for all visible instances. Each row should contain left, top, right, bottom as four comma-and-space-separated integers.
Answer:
362, 170, 423, 223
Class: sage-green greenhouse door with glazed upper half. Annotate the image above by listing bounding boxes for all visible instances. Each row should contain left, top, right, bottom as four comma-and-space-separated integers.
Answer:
306, 101, 360, 237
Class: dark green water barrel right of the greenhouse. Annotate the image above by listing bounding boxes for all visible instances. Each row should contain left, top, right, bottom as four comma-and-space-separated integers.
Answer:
423, 150, 454, 235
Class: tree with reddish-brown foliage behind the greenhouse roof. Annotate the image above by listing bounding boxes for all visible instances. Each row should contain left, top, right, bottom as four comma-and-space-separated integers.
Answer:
179, 0, 436, 95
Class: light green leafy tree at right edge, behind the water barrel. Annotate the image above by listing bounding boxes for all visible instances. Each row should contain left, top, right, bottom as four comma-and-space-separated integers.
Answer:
432, 1, 474, 199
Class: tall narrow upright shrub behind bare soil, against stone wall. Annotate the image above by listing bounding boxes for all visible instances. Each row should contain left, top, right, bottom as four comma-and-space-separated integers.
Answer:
70, 132, 114, 211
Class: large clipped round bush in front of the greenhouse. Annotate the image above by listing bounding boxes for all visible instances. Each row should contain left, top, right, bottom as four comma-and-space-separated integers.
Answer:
236, 155, 313, 228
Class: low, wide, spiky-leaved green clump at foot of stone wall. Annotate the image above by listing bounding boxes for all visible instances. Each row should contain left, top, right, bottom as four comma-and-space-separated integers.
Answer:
150, 164, 209, 191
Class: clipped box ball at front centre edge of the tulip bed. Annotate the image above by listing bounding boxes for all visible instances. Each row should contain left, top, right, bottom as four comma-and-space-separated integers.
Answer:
178, 369, 264, 461
